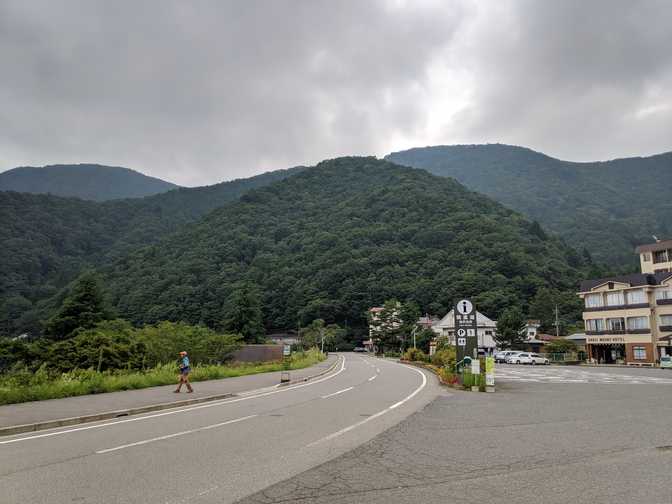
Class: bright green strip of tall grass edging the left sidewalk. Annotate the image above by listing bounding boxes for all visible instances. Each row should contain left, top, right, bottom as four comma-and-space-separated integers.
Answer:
0, 349, 325, 405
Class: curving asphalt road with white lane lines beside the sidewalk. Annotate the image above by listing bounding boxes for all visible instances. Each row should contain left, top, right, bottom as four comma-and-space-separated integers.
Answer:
0, 354, 441, 504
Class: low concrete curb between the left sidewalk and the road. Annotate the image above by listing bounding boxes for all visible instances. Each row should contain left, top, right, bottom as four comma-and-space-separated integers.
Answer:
0, 357, 341, 437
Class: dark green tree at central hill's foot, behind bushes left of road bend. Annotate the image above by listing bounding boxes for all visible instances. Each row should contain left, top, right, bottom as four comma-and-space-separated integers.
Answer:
224, 282, 266, 343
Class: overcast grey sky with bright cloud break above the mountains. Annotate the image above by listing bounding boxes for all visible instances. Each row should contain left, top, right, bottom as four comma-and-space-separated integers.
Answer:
0, 0, 672, 186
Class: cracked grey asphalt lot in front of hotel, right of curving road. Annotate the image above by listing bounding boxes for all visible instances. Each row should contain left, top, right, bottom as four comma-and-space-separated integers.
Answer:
241, 365, 672, 504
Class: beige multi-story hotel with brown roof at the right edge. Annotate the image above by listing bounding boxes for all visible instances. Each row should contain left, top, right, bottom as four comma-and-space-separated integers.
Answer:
579, 240, 672, 365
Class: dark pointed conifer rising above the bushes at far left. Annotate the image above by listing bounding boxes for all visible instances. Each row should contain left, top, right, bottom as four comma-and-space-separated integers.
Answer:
45, 272, 112, 340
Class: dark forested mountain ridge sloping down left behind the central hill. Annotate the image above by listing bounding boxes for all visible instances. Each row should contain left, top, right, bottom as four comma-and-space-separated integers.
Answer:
0, 167, 302, 334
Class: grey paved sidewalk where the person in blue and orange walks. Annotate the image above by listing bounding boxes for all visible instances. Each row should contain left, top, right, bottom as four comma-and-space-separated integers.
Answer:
0, 354, 338, 435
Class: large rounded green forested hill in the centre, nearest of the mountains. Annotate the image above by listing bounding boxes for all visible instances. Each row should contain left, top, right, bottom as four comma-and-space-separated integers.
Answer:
101, 158, 581, 330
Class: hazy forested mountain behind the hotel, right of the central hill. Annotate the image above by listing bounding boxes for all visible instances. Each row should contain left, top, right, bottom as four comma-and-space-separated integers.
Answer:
386, 144, 672, 267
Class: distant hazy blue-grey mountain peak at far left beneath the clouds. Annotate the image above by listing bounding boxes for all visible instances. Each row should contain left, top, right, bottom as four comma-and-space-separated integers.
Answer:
0, 164, 178, 201
